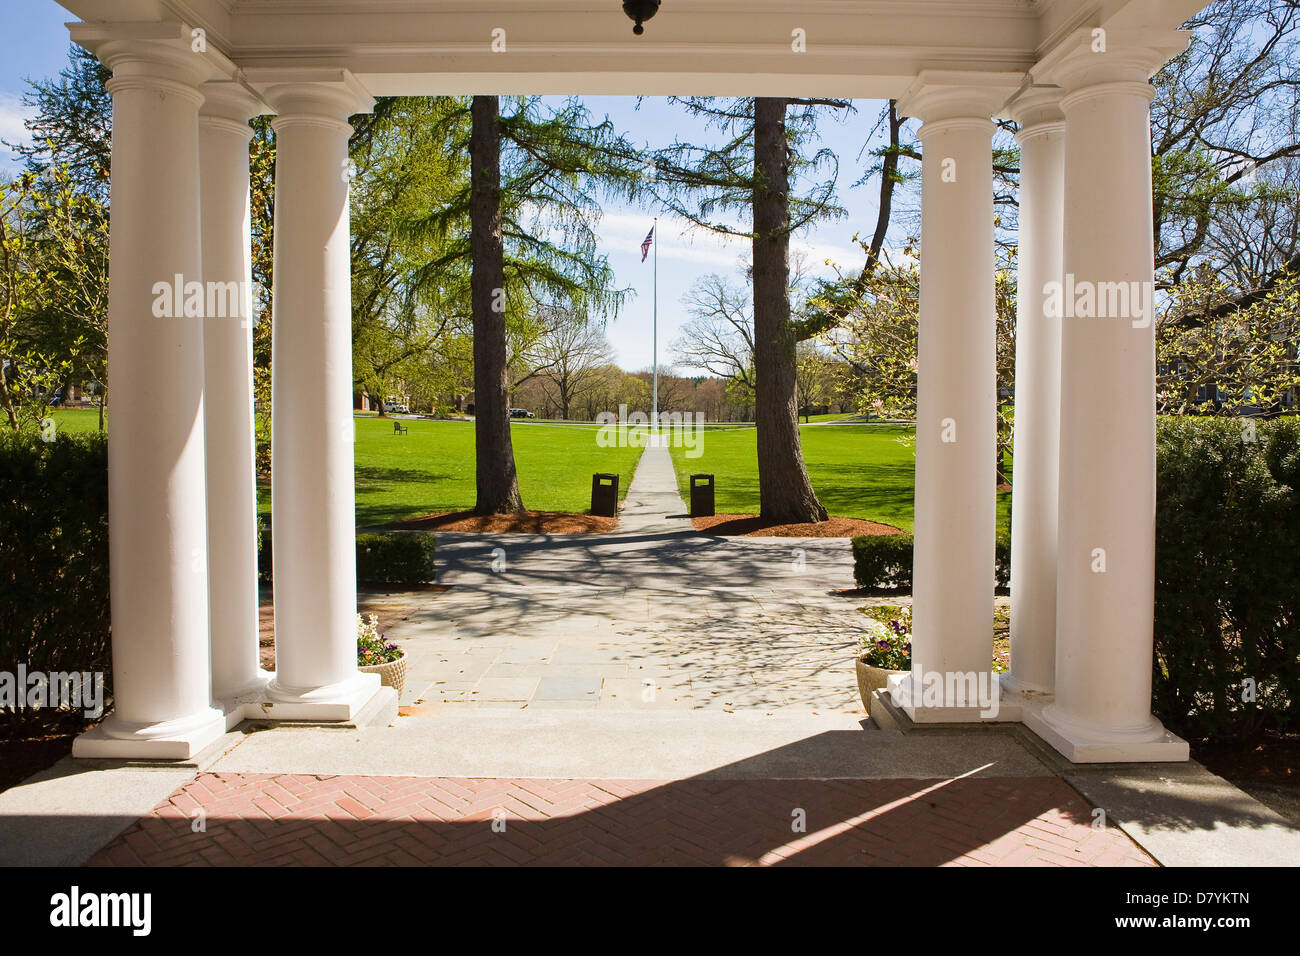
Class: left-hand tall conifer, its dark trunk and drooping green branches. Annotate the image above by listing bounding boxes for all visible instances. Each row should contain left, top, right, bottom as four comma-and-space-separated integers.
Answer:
411, 96, 645, 514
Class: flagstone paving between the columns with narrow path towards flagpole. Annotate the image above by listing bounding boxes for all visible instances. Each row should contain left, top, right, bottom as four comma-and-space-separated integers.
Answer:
387, 447, 863, 713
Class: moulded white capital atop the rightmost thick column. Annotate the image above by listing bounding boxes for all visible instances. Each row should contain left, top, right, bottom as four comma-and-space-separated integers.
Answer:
1030, 27, 1192, 94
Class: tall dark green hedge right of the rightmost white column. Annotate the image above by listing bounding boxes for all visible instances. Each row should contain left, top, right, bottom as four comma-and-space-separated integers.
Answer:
1152, 419, 1300, 740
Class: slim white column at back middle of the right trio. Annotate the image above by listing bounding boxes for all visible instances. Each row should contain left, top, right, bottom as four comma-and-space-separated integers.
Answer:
998, 87, 1065, 693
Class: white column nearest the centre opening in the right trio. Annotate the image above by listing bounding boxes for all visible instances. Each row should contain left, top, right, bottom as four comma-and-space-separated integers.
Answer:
891, 77, 1009, 722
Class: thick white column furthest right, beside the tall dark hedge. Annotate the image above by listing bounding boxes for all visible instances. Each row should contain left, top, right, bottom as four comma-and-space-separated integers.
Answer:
1026, 40, 1187, 762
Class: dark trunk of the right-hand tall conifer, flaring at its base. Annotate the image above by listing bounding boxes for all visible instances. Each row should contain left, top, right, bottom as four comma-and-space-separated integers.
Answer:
754, 96, 827, 524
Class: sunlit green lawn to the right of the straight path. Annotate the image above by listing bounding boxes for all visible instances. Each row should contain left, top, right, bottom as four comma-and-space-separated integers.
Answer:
672, 425, 1011, 531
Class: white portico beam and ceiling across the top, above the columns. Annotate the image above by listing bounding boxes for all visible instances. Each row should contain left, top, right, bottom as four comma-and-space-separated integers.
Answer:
59, 0, 1204, 98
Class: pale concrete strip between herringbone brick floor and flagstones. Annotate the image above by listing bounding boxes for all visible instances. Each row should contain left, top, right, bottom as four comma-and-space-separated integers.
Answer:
212, 708, 1050, 780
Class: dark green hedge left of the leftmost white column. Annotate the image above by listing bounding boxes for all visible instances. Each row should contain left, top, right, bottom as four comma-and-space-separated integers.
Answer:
0, 431, 111, 693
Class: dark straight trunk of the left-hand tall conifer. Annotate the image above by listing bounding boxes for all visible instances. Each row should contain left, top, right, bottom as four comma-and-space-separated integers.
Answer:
469, 96, 524, 515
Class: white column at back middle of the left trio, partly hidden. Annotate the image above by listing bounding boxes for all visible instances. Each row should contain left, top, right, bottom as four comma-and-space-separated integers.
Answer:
199, 81, 268, 721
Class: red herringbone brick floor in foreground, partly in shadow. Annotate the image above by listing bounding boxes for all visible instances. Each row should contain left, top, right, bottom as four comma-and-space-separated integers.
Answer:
91, 774, 1156, 866
